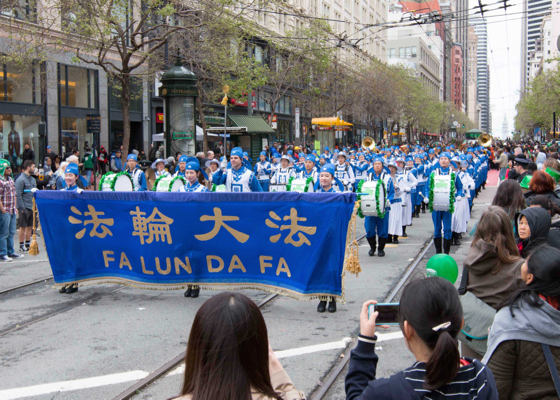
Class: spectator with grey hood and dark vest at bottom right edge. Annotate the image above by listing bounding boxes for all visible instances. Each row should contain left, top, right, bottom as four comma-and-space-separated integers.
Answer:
483, 245, 560, 400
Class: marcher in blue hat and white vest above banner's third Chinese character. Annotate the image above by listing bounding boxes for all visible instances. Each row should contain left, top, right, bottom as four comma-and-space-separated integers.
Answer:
212, 147, 263, 193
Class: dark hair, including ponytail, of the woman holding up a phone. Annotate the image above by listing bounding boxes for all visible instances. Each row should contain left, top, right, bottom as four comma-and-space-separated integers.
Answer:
399, 277, 463, 390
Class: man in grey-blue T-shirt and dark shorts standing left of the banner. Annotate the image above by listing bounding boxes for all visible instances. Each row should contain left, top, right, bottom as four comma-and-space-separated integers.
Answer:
16, 160, 37, 251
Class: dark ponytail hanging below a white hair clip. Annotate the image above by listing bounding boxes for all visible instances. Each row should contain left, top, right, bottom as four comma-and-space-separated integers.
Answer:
424, 330, 460, 390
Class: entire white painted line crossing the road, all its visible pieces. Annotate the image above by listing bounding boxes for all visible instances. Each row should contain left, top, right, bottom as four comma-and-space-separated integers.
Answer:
0, 332, 403, 400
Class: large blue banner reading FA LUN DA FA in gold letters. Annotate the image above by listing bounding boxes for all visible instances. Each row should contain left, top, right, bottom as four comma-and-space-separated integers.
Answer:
35, 191, 356, 300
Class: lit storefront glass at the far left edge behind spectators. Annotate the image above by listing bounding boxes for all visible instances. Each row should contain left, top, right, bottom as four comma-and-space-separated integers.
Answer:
0, 62, 45, 172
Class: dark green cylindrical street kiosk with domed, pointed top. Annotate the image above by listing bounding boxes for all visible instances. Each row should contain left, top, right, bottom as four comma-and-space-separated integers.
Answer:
159, 57, 198, 157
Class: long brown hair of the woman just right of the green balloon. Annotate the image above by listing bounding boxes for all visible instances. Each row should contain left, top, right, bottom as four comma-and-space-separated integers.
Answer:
471, 206, 521, 266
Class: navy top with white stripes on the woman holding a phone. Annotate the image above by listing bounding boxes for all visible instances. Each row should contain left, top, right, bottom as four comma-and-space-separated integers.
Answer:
345, 341, 498, 400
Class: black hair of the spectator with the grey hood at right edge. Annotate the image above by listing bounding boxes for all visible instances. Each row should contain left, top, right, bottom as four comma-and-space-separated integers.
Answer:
509, 244, 560, 317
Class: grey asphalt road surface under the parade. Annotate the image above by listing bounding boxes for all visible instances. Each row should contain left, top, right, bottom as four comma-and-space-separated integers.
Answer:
0, 182, 495, 400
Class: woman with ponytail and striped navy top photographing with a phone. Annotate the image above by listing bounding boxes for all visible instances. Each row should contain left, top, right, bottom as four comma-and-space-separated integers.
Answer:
345, 277, 498, 400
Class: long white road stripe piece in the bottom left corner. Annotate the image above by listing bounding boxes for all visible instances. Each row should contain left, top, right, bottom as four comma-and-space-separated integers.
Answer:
0, 371, 149, 400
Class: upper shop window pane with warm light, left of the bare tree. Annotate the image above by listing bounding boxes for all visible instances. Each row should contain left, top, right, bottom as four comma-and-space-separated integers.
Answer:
58, 64, 98, 108
